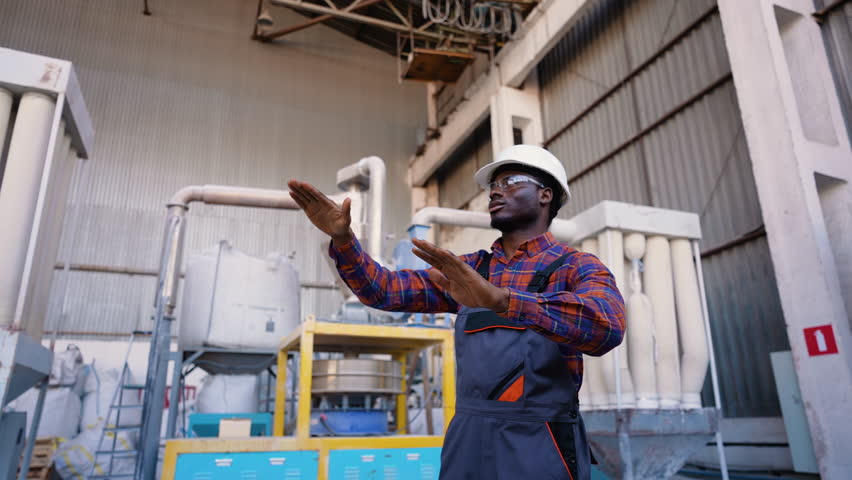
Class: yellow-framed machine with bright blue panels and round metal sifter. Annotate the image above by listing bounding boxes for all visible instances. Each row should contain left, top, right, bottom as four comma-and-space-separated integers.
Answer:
162, 318, 455, 480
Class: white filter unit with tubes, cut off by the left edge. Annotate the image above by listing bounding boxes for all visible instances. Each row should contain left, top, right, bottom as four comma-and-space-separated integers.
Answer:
0, 48, 94, 478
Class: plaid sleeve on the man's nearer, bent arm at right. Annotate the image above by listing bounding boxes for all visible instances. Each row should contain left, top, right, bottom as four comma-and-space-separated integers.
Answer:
500, 253, 626, 356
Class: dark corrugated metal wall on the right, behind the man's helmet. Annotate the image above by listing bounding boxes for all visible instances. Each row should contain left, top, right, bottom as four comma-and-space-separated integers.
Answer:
539, 0, 789, 417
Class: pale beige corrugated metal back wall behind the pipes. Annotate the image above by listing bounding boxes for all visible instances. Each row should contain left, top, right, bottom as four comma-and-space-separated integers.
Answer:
0, 0, 425, 333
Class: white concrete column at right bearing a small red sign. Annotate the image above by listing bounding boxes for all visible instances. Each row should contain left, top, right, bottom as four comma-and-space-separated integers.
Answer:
718, 0, 852, 472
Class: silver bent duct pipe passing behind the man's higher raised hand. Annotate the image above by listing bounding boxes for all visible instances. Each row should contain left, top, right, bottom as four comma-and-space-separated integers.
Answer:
135, 157, 385, 479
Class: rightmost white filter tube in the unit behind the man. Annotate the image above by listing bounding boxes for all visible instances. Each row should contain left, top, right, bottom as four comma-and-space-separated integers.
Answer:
670, 238, 710, 408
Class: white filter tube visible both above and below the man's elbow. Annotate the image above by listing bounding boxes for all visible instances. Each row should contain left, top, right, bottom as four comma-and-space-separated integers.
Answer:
598, 230, 636, 407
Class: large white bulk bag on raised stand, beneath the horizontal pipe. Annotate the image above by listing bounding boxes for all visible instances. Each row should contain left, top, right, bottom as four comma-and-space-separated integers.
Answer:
179, 241, 300, 349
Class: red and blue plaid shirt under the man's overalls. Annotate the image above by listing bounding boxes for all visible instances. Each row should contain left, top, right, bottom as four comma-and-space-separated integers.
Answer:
329, 232, 626, 387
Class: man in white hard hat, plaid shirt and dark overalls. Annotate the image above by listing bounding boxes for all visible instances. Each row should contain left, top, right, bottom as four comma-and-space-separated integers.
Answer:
289, 145, 625, 480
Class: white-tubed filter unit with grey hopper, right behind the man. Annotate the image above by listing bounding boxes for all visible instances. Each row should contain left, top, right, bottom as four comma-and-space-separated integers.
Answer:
572, 201, 728, 480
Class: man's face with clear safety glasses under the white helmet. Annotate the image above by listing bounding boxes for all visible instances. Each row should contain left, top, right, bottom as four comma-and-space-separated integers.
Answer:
488, 170, 543, 232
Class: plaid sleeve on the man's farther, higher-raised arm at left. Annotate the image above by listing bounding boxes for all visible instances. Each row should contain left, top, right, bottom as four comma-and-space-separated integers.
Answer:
329, 238, 479, 313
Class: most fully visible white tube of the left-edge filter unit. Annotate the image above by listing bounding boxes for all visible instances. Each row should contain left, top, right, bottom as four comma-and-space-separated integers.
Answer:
0, 92, 55, 325
